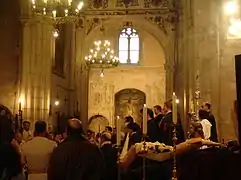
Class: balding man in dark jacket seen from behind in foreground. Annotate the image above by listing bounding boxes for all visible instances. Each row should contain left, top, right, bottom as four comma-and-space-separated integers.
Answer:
48, 119, 104, 180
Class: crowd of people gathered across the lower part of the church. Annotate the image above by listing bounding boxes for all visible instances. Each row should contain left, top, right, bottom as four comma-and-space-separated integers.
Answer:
0, 101, 220, 180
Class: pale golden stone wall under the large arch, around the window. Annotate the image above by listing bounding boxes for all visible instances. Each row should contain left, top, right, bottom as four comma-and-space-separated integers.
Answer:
85, 17, 166, 125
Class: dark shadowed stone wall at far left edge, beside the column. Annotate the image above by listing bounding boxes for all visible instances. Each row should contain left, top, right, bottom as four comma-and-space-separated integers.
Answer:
0, 0, 21, 112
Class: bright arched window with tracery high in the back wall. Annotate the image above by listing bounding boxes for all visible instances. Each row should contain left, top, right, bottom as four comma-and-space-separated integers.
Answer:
119, 27, 140, 64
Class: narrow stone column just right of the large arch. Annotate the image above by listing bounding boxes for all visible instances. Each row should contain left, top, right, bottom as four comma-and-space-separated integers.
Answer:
175, 0, 196, 131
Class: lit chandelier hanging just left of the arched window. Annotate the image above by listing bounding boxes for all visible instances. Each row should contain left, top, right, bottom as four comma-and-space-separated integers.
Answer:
85, 40, 119, 70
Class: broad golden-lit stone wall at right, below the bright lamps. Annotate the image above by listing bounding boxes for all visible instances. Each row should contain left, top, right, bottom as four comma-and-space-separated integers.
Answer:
176, 0, 241, 141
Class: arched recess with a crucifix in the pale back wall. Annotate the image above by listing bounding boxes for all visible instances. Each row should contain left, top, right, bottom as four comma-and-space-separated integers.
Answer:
115, 89, 146, 123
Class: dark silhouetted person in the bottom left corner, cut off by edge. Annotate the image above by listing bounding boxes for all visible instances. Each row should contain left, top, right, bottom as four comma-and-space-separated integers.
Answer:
0, 116, 24, 180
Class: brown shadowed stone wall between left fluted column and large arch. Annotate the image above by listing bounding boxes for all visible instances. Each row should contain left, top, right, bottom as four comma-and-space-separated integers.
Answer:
51, 24, 78, 126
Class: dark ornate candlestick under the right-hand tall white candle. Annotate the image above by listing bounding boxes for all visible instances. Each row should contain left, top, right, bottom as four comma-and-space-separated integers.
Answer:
172, 123, 178, 180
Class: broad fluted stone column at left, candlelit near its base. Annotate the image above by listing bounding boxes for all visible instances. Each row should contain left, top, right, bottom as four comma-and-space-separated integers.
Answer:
19, 19, 53, 122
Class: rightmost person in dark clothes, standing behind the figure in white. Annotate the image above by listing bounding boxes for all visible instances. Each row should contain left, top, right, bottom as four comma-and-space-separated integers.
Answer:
203, 103, 218, 142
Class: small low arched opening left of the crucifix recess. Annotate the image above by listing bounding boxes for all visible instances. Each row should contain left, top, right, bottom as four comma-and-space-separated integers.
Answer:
89, 114, 109, 134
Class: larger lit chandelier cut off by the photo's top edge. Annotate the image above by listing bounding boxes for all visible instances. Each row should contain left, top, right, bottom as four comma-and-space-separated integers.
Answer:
32, 0, 84, 23
